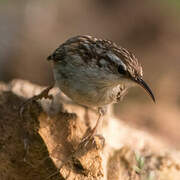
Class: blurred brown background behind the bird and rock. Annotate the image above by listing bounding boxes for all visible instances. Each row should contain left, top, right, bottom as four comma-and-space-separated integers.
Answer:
0, 0, 180, 149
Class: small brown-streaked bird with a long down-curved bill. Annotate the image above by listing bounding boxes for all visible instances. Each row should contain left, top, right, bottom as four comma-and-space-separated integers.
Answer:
47, 35, 155, 139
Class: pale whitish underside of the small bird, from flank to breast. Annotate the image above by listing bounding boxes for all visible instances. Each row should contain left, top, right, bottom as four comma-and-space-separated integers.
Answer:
53, 58, 125, 107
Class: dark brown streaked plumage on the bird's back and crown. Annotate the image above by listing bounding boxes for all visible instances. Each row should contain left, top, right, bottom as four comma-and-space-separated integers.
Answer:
48, 36, 143, 77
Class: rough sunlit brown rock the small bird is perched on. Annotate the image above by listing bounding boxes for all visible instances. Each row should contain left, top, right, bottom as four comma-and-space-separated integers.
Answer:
0, 80, 180, 180
